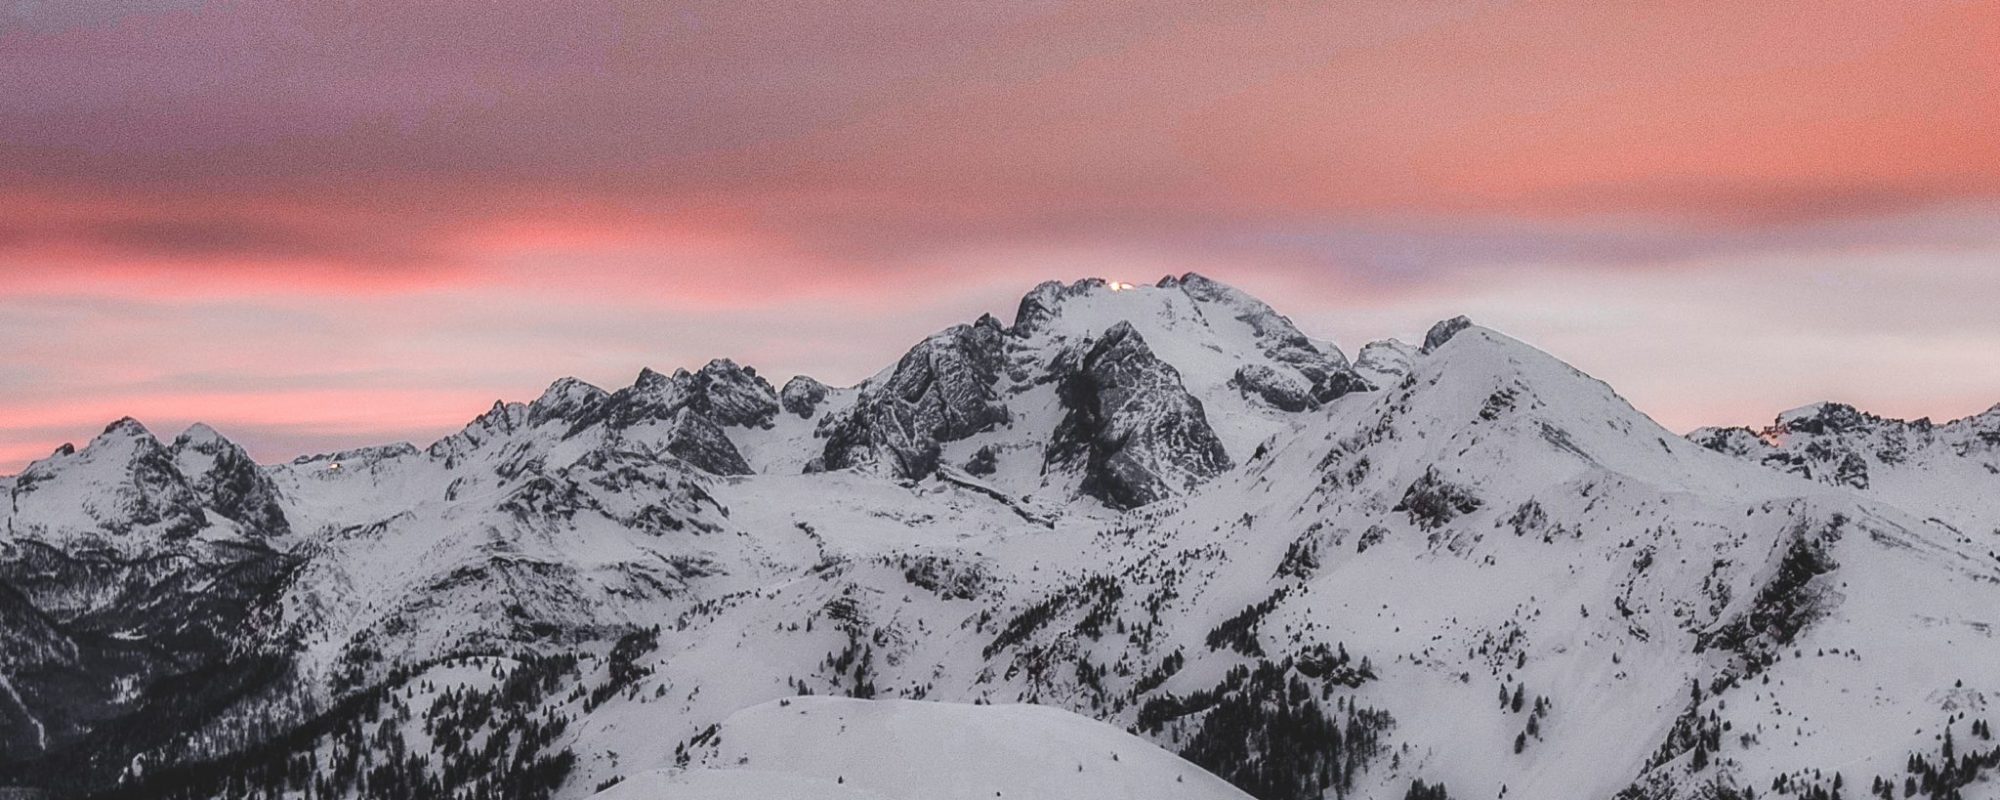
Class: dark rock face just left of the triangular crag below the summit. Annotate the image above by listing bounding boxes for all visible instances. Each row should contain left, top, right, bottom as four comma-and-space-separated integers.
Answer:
808, 316, 1008, 478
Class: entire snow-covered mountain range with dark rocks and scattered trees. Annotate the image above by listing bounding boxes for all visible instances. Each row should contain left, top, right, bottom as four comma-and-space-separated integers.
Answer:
0, 274, 2000, 798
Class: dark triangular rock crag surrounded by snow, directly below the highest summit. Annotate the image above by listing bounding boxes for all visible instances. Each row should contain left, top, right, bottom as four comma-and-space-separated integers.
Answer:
1044, 322, 1232, 508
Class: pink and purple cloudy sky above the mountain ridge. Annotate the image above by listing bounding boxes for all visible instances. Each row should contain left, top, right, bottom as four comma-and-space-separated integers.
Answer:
0, 0, 2000, 472
